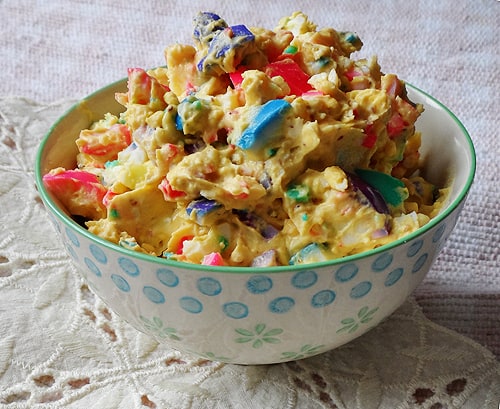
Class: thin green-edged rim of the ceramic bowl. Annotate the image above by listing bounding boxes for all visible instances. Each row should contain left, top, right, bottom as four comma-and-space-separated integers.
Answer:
35, 78, 476, 274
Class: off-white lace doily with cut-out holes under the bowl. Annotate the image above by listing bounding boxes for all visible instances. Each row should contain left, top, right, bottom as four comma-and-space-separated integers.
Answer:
0, 98, 500, 409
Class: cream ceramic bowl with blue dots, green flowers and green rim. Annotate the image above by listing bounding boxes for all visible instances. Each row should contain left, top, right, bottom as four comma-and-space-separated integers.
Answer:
36, 80, 475, 364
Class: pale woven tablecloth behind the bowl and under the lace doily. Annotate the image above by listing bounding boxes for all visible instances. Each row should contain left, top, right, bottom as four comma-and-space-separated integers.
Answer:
0, 0, 500, 407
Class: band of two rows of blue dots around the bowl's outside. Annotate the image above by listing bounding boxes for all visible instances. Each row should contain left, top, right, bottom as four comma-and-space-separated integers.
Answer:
71, 223, 449, 328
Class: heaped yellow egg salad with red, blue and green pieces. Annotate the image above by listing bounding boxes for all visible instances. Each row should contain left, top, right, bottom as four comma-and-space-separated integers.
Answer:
44, 12, 445, 267
